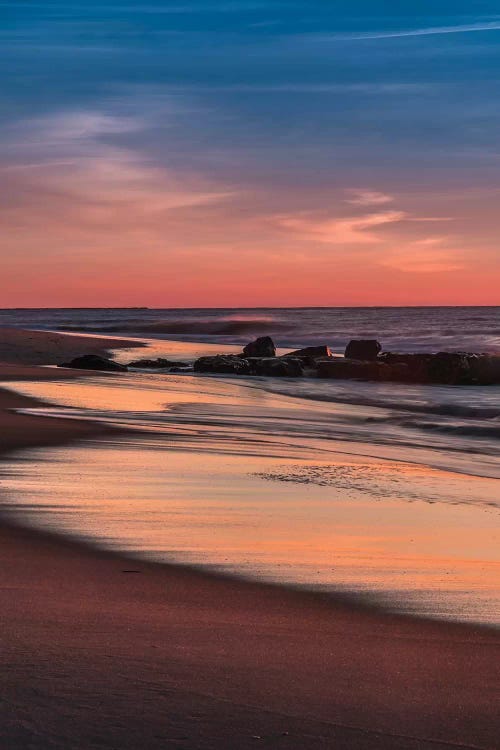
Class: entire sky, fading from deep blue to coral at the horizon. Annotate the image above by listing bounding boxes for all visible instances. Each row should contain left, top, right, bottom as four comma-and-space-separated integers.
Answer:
0, 0, 500, 307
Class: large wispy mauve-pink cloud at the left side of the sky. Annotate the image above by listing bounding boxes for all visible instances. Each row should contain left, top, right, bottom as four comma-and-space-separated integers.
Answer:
3, 110, 230, 223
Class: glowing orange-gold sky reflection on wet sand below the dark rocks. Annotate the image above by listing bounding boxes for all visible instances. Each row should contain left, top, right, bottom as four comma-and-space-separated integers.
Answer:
2, 374, 500, 623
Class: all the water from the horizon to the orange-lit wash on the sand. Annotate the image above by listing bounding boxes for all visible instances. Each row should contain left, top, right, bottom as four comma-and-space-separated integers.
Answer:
0, 308, 500, 624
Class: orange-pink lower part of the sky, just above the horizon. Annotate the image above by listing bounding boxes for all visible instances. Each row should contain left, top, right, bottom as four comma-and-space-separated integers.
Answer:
2, 145, 500, 307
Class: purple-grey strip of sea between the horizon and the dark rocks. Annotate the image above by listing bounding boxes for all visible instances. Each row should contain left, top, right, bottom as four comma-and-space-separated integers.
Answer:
0, 307, 500, 352
